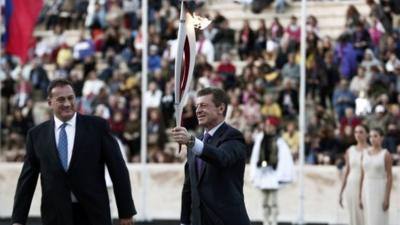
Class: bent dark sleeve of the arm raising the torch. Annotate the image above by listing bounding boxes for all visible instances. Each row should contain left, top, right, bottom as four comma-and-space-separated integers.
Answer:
200, 131, 246, 168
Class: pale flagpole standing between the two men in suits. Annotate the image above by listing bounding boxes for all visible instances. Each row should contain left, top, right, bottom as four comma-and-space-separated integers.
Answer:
140, 0, 149, 221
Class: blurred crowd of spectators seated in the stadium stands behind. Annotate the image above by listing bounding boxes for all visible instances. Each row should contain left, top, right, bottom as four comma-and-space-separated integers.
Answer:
0, 0, 400, 167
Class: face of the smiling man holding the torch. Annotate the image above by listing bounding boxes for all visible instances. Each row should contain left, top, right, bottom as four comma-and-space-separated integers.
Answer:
196, 94, 225, 130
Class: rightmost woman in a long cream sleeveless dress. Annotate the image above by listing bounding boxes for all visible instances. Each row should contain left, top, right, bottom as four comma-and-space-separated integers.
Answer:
360, 128, 392, 225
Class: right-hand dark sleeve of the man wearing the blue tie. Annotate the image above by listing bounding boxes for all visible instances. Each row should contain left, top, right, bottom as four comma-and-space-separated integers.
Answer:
102, 121, 136, 218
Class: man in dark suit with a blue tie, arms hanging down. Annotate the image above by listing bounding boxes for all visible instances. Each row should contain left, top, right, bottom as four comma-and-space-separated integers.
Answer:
12, 79, 136, 225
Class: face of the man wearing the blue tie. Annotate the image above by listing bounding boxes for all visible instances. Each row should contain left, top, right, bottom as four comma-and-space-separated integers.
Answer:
48, 85, 75, 122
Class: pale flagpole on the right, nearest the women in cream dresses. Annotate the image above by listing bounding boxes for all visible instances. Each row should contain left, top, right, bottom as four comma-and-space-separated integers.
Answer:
297, 0, 307, 225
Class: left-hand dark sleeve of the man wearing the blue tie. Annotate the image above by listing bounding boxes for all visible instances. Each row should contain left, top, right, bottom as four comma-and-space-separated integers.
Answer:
12, 132, 40, 224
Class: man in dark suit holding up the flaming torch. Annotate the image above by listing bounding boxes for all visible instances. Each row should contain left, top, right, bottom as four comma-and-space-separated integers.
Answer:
172, 88, 250, 225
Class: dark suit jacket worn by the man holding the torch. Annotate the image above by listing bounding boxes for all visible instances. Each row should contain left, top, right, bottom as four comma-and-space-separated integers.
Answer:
181, 123, 250, 225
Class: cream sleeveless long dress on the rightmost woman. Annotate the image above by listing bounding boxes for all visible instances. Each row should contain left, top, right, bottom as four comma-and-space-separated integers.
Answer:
362, 150, 389, 225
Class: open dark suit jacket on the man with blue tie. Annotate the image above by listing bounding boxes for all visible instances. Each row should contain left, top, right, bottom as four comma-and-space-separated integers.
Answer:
12, 114, 136, 225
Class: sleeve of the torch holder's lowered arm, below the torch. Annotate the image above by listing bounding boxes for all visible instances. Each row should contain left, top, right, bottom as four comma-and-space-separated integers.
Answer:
181, 162, 192, 224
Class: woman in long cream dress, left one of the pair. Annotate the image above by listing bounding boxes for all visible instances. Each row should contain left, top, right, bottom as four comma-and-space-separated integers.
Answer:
339, 125, 369, 225
